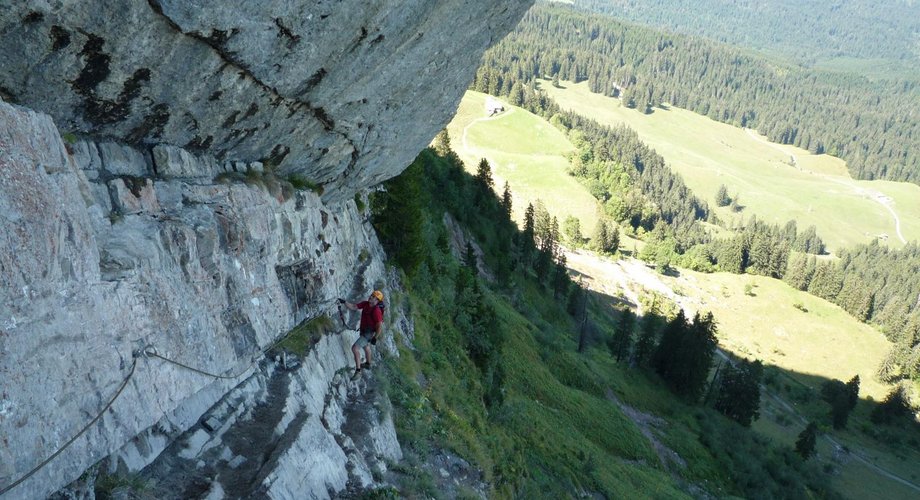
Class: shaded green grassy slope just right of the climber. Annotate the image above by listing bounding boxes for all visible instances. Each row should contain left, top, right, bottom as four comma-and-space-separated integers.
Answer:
388, 268, 699, 498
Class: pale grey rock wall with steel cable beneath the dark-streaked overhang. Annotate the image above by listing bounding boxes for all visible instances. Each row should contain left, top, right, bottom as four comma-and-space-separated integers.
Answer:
0, 99, 405, 498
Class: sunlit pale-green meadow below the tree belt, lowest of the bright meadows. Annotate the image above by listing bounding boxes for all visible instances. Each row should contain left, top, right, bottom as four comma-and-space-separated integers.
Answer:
662, 269, 891, 400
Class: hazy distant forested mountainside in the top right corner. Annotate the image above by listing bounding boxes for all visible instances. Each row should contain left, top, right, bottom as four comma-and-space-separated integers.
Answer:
575, 0, 920, 67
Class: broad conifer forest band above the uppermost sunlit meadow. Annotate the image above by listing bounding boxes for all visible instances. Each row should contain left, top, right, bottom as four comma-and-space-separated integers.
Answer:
474, 5, 920, 183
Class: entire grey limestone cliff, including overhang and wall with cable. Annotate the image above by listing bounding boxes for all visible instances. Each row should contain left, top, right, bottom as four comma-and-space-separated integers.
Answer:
0, 0, 531, 499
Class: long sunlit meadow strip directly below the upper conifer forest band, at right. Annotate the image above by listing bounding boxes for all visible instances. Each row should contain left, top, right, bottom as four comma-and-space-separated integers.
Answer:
541, 82, 920, 249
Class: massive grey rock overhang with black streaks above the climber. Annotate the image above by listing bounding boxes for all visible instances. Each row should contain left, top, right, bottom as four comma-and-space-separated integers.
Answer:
0, 0, 533, 201
